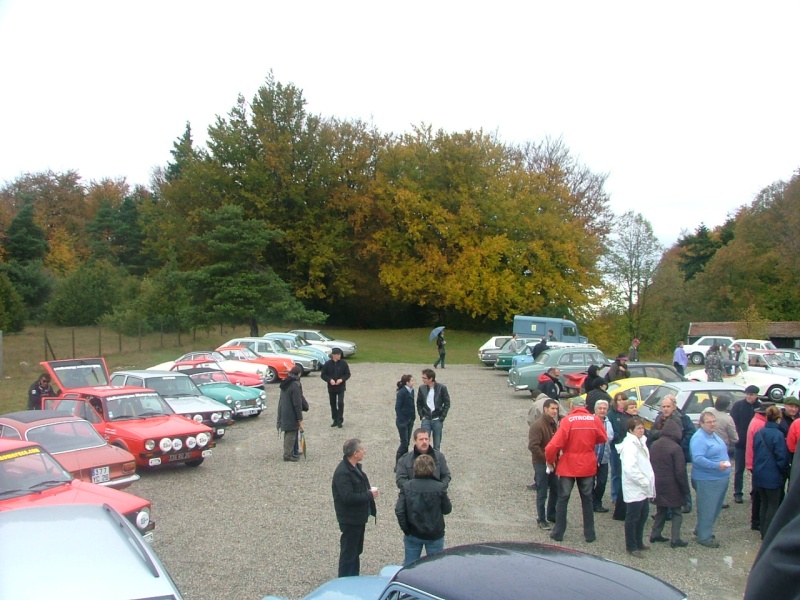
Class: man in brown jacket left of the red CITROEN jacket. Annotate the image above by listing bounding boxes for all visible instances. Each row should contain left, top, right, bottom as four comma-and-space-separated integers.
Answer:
528, 399, 558, 531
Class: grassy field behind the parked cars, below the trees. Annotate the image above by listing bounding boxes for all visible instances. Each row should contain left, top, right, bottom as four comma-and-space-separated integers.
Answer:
0, 327, 490, 414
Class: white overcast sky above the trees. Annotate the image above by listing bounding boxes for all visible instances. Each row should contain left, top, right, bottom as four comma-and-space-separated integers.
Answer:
0, 0, 800, 243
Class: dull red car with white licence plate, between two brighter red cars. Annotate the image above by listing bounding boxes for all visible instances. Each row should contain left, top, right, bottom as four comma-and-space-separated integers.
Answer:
0, 410, 139, 490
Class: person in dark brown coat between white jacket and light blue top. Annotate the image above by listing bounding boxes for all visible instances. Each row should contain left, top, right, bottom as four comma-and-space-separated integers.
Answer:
650, 419, 691, 548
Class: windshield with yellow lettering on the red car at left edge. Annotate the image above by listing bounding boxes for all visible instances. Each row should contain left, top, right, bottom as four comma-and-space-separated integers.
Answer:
0, 447, 72, 499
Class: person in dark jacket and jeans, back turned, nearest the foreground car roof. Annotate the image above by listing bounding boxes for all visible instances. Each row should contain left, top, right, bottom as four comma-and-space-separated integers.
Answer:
394, 454, 453, 566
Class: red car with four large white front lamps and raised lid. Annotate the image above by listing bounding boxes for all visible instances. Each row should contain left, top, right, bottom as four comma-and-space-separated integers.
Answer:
41, 358, 214, 467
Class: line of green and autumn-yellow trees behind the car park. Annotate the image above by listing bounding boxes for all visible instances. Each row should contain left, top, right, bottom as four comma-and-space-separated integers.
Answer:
0, 75, 797, 348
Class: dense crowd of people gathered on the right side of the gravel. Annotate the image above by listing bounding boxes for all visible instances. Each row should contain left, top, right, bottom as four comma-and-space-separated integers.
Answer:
528, 376, 800, 557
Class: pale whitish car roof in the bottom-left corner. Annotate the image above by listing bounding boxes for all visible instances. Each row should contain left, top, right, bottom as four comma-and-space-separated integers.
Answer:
0, 504, 180, 600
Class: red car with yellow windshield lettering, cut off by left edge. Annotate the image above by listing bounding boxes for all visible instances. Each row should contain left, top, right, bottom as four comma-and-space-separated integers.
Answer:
0, 439, 155, 540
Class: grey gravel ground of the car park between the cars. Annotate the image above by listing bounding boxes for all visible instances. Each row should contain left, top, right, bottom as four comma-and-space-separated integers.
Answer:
129, 363, 760, 600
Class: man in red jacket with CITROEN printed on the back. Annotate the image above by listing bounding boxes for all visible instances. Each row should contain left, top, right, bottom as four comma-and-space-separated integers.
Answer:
544, 400, 608, 542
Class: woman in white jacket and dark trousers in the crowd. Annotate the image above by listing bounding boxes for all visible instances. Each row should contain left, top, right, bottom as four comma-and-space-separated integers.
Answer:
617, 417, 656, 558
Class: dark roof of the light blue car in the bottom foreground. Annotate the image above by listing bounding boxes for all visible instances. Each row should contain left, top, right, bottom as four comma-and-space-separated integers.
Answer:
392, 542, 685, 600
